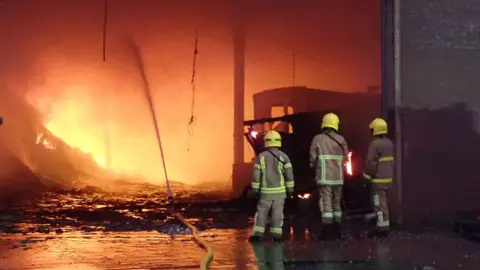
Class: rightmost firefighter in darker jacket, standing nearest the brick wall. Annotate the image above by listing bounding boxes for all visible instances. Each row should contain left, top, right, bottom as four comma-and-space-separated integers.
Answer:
363, 118, 395, 236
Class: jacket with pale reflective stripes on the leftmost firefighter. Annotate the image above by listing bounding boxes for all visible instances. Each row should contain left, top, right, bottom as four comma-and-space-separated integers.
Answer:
252, 148, 295, 200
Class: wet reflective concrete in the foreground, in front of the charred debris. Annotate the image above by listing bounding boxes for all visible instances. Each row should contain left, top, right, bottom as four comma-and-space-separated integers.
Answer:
0, 229, 480, 270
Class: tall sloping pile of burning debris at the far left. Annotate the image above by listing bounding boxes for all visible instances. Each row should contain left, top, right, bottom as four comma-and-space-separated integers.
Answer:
0, 91, 119, 197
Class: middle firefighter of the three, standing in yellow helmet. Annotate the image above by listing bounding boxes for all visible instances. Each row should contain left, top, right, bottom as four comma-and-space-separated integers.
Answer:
310, 113, 348, 239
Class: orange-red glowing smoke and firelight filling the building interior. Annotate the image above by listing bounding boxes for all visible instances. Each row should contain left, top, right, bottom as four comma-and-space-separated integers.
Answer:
0, 0, 380, 186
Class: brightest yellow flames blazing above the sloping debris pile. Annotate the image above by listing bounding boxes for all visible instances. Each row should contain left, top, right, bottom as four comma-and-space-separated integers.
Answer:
27, 88, 144, 184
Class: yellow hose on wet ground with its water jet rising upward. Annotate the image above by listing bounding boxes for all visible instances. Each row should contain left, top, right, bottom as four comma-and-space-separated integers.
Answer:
129, 40, 213, 270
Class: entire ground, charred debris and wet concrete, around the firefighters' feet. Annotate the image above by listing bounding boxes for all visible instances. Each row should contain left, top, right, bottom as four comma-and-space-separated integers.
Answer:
0, 191, 480, 270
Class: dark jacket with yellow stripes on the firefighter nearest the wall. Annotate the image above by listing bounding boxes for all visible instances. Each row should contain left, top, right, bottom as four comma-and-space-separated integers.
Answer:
363, 137, 395, 188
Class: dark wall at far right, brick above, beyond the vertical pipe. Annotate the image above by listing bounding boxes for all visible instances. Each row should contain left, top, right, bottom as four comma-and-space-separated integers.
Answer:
396, 0, 480, 222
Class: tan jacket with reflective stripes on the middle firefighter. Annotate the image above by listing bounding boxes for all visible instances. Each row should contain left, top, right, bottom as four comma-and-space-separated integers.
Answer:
310, 132, 348, 186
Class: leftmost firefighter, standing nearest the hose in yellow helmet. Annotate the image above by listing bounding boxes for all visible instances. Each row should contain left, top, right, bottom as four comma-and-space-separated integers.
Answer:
250, 130, 294, 241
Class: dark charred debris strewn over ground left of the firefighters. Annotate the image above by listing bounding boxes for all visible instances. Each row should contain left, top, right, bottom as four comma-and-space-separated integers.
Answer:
0, 184, 249, 235
